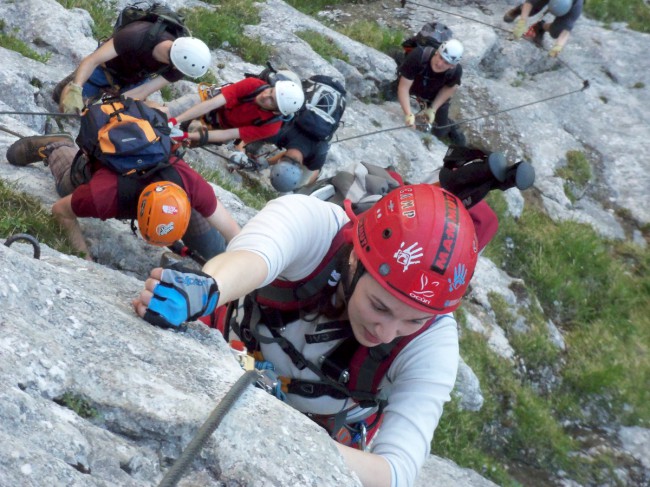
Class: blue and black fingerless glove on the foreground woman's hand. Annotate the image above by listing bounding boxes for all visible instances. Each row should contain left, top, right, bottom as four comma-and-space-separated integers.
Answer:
144, 263, 219, 328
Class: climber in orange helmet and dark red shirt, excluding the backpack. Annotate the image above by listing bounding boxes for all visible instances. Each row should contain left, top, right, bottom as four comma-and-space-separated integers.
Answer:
7, 134, 239, 260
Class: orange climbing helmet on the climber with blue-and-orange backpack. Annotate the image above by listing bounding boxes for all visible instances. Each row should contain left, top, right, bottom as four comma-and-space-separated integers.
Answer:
137, 181, 192, 247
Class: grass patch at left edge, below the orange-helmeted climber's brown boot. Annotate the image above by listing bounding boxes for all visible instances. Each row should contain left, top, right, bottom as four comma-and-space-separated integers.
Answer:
0, 180, 77, 255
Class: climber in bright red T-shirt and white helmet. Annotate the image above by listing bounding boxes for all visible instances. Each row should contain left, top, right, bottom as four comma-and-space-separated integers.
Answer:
170, 78, 305, 145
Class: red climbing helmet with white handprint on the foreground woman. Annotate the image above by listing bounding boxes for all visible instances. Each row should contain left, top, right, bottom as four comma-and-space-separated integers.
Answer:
346, 184, 478, 314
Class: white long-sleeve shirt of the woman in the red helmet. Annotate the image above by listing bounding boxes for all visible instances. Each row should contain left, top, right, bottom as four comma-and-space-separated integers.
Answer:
228, 195, 459, 487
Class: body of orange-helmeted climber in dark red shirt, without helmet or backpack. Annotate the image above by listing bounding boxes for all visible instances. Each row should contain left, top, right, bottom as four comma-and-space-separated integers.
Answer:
7, 134, 240, 260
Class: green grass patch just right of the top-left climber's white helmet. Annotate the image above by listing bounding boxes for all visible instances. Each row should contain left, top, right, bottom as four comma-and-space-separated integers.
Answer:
181, 0, 273, 64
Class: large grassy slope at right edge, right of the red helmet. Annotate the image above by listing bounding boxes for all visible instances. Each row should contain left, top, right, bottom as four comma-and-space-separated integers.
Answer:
486, 195, 650, 425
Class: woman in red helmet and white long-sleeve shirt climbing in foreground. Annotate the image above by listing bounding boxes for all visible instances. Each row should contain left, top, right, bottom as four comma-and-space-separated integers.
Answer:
133, 184, 479, 487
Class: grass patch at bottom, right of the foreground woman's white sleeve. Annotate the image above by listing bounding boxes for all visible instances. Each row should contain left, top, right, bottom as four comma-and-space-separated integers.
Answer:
432, 329, 579, 486
